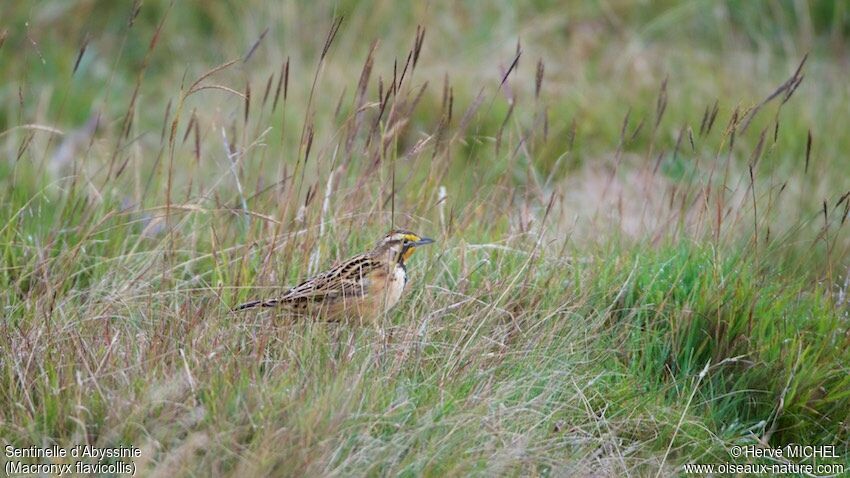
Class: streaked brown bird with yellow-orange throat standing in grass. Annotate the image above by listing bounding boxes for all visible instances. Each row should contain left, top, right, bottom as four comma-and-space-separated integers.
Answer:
233, 229, 434, 323
